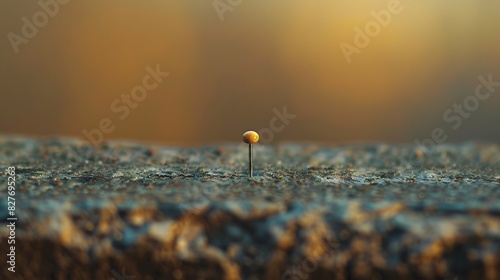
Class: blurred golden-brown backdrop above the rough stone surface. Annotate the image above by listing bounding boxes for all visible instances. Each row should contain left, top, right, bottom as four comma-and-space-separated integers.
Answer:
0, 0, 500, 145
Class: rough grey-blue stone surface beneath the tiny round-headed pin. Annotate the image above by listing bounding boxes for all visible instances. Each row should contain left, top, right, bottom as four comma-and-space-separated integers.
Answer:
0, 137, 500, 280
